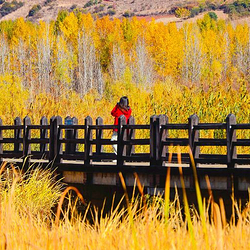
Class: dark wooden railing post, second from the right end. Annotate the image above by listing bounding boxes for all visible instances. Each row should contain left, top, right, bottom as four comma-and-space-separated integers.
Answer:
188, 114, 200, 163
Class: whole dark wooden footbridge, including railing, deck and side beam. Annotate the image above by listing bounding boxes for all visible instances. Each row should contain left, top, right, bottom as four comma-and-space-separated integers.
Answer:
0, 114, 250, 192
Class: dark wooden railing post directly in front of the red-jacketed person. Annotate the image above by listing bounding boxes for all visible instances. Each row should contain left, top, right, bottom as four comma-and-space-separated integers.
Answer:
117, 115, 127, 166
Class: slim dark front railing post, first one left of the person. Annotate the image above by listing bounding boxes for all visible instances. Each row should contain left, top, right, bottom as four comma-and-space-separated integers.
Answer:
84, 116, 93, 165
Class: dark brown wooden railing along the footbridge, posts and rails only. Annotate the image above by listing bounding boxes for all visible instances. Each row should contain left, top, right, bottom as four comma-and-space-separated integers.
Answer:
0, 114, 250, 168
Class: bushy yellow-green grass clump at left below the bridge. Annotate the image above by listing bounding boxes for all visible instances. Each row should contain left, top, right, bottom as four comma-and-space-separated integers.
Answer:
0, 166, 63, 217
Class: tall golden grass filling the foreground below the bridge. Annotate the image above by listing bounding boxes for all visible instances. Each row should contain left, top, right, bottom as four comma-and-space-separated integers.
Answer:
0, 161, 250, 249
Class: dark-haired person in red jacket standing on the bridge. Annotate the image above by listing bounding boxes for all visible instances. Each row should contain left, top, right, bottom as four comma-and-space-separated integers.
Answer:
111, 96, 132, 154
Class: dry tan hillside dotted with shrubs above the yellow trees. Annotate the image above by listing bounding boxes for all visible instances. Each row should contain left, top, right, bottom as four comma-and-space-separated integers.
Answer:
0, 0, 250, 22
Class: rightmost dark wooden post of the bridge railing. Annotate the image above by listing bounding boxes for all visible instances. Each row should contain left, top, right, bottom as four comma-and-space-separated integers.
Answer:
226, 114, 237, 168
